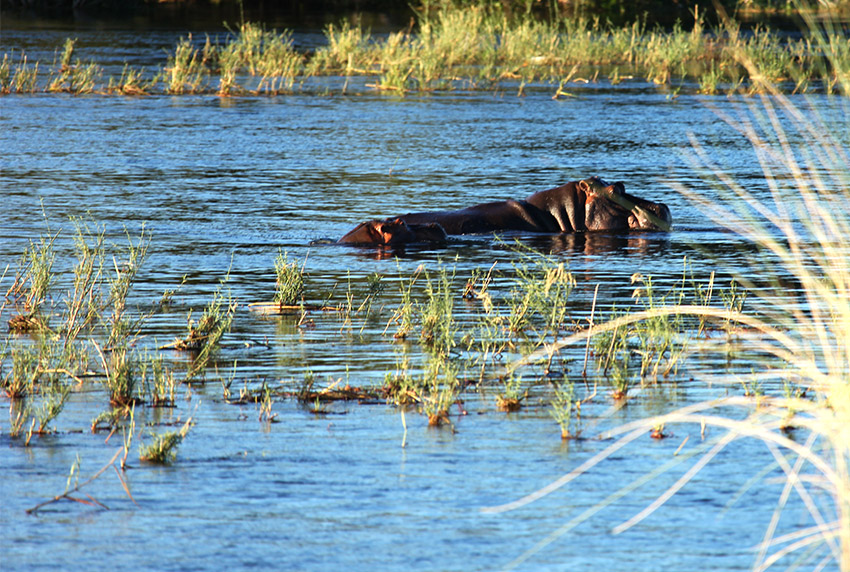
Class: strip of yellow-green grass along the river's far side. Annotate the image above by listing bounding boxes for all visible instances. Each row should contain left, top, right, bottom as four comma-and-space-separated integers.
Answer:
0, 5, 850, 97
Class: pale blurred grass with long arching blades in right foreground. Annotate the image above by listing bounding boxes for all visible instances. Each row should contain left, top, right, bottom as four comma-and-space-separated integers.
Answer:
488, 13, 850, 570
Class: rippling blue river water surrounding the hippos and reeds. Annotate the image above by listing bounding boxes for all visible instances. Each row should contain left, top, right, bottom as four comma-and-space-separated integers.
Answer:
0, 25, 843, 571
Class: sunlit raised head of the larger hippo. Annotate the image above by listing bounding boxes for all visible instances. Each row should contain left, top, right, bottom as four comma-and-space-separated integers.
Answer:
578, 177, 673, 231
